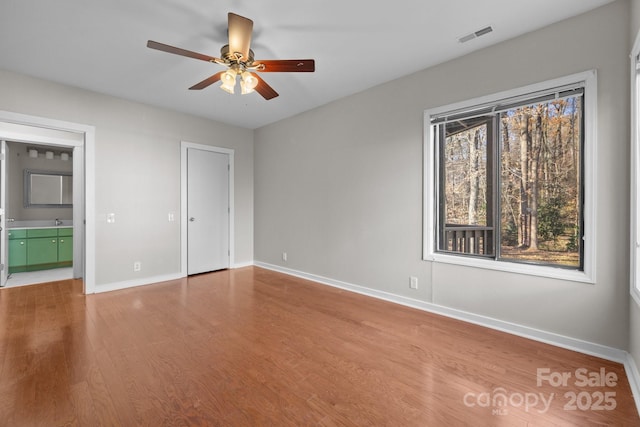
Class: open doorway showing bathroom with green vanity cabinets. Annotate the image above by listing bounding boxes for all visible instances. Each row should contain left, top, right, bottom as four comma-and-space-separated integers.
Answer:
2, 141, 77, 288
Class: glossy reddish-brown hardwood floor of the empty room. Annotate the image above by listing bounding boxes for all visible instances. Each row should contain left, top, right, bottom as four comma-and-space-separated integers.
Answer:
0, 267, 640, 427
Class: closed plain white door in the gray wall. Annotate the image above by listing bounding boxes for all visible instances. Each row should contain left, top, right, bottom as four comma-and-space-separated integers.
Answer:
187, 148, 230, 274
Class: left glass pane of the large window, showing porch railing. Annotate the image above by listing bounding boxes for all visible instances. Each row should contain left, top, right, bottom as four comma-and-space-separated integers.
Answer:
439, 116, 493, 255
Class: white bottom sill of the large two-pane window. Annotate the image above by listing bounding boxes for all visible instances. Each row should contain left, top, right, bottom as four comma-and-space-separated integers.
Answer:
425, 253, 595, 284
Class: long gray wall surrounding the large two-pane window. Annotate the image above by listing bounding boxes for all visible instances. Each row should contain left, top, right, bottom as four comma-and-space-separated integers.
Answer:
254, 0, 630, 349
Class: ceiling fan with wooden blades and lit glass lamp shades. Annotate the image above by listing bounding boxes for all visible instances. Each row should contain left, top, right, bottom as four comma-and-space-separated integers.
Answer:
147, 13, 315, 100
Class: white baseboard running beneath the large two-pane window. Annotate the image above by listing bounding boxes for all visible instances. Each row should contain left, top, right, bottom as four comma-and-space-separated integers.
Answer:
254, 261, 640, 411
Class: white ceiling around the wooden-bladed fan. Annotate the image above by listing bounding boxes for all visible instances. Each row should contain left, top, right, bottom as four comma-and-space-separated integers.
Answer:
0, 0, 612, 129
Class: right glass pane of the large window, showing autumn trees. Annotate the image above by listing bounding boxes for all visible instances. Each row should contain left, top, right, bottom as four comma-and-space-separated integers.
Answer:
500, 96, 583, 268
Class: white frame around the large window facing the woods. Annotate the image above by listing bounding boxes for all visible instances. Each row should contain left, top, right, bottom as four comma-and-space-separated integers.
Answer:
423, 70, 598, 284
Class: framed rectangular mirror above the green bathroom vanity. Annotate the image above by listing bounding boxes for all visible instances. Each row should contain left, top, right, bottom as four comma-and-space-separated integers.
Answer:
24, 169, 73, 208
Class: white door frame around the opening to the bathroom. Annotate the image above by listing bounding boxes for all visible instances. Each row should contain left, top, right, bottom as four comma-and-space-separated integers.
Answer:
0, 110, 96, 294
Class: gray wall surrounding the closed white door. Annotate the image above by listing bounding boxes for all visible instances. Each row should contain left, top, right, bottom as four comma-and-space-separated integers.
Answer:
0, 71, 253, 290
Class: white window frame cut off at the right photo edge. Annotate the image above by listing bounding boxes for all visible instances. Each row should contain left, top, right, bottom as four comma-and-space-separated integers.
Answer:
629, 32, 640, 306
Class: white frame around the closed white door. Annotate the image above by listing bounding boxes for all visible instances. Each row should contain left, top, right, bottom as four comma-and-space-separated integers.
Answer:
180, 141, 235, 277
